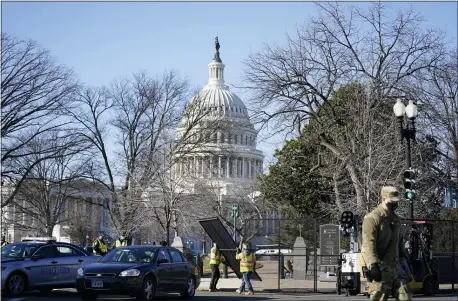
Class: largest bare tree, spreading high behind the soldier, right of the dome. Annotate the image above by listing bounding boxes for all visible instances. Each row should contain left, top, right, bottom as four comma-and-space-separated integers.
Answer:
243, 3, 444, 212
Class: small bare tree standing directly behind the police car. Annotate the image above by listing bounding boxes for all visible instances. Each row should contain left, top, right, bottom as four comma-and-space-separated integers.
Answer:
3, 132, 92, 236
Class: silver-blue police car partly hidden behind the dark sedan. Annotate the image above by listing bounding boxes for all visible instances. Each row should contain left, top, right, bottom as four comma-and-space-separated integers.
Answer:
1, 237, 101, 297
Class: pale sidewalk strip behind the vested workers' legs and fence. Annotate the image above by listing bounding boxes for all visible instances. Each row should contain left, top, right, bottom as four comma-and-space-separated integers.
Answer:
197, 274, 336, 293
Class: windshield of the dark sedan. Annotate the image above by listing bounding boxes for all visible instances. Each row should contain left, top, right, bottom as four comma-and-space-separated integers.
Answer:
99, 247, 157, 263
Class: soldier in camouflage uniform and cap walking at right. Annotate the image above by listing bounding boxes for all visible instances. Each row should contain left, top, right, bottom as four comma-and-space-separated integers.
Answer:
361, 186, 401, 301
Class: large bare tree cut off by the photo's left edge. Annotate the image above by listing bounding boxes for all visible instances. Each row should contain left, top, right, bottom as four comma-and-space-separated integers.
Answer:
1, 33, 77, 208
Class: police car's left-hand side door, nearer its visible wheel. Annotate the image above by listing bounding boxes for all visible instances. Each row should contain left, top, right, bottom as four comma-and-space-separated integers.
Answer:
25, 245, 57, 286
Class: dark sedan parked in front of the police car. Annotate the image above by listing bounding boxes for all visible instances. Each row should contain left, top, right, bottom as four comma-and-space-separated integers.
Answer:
76, 246, 200, 300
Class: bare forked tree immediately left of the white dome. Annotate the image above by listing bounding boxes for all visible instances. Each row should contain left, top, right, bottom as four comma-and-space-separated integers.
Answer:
70, 72, 204, 236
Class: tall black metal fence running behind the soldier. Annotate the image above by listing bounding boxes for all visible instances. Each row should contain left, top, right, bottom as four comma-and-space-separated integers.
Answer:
240, 219, 458, 292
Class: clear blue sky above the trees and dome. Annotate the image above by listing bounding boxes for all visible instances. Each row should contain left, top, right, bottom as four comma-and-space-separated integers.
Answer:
2, 2, 458, 163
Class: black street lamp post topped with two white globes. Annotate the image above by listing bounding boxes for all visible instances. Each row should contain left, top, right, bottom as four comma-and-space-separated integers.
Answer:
393, 98, 418, 219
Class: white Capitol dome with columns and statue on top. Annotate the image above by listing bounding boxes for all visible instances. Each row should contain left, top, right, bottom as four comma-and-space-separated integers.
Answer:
174, 39, 264, 194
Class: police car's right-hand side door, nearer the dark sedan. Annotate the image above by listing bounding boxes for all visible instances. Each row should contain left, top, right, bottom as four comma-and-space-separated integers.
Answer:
56, 245, 85, 284
